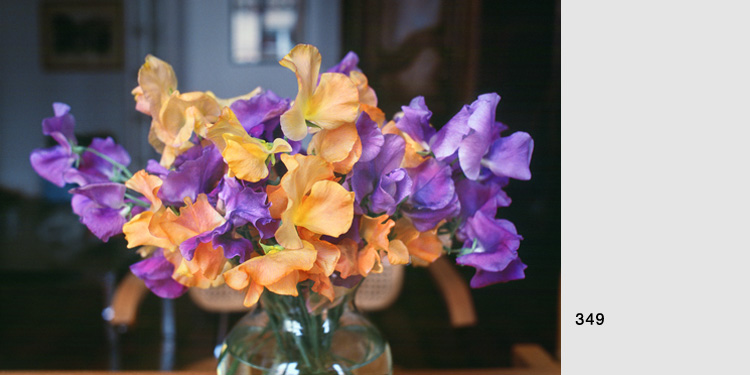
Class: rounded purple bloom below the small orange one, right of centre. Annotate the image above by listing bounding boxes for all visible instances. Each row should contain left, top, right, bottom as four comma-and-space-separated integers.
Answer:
404, 159, 460, 232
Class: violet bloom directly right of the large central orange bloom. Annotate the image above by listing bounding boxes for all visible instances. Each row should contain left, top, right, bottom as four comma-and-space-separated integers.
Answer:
350, 134, 412, 215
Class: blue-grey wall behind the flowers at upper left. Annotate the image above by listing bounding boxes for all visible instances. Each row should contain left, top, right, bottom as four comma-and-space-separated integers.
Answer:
0, 0, 343, 196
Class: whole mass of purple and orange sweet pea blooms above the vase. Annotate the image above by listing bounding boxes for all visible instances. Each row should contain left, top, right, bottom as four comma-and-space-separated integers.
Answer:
31, 45, 533, 372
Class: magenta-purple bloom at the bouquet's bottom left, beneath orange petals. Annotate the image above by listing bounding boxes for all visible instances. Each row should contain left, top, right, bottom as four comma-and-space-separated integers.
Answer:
130, 249, 188, 298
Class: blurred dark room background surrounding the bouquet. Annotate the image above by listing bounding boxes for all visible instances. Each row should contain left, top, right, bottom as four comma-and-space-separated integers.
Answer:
0, 0, 560, 370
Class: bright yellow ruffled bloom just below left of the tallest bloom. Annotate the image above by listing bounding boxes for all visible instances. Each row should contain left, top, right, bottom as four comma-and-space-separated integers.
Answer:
206, 107, 292, 182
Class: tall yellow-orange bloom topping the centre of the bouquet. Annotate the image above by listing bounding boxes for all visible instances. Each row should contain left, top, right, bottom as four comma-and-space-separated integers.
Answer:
279, 44, 359, 141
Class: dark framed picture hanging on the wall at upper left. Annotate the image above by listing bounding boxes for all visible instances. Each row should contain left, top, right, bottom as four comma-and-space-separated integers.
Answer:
40, 0, 124, 71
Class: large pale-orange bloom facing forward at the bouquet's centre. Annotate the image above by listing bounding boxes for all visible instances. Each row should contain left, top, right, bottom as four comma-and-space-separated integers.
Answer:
268, 154, 354, 249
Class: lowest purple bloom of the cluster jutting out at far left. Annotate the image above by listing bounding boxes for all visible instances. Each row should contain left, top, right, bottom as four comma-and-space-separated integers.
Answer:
70, 182, 128, 242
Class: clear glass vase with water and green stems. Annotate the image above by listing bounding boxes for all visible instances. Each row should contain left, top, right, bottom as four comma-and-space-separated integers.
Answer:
217, 281, 392, 375
